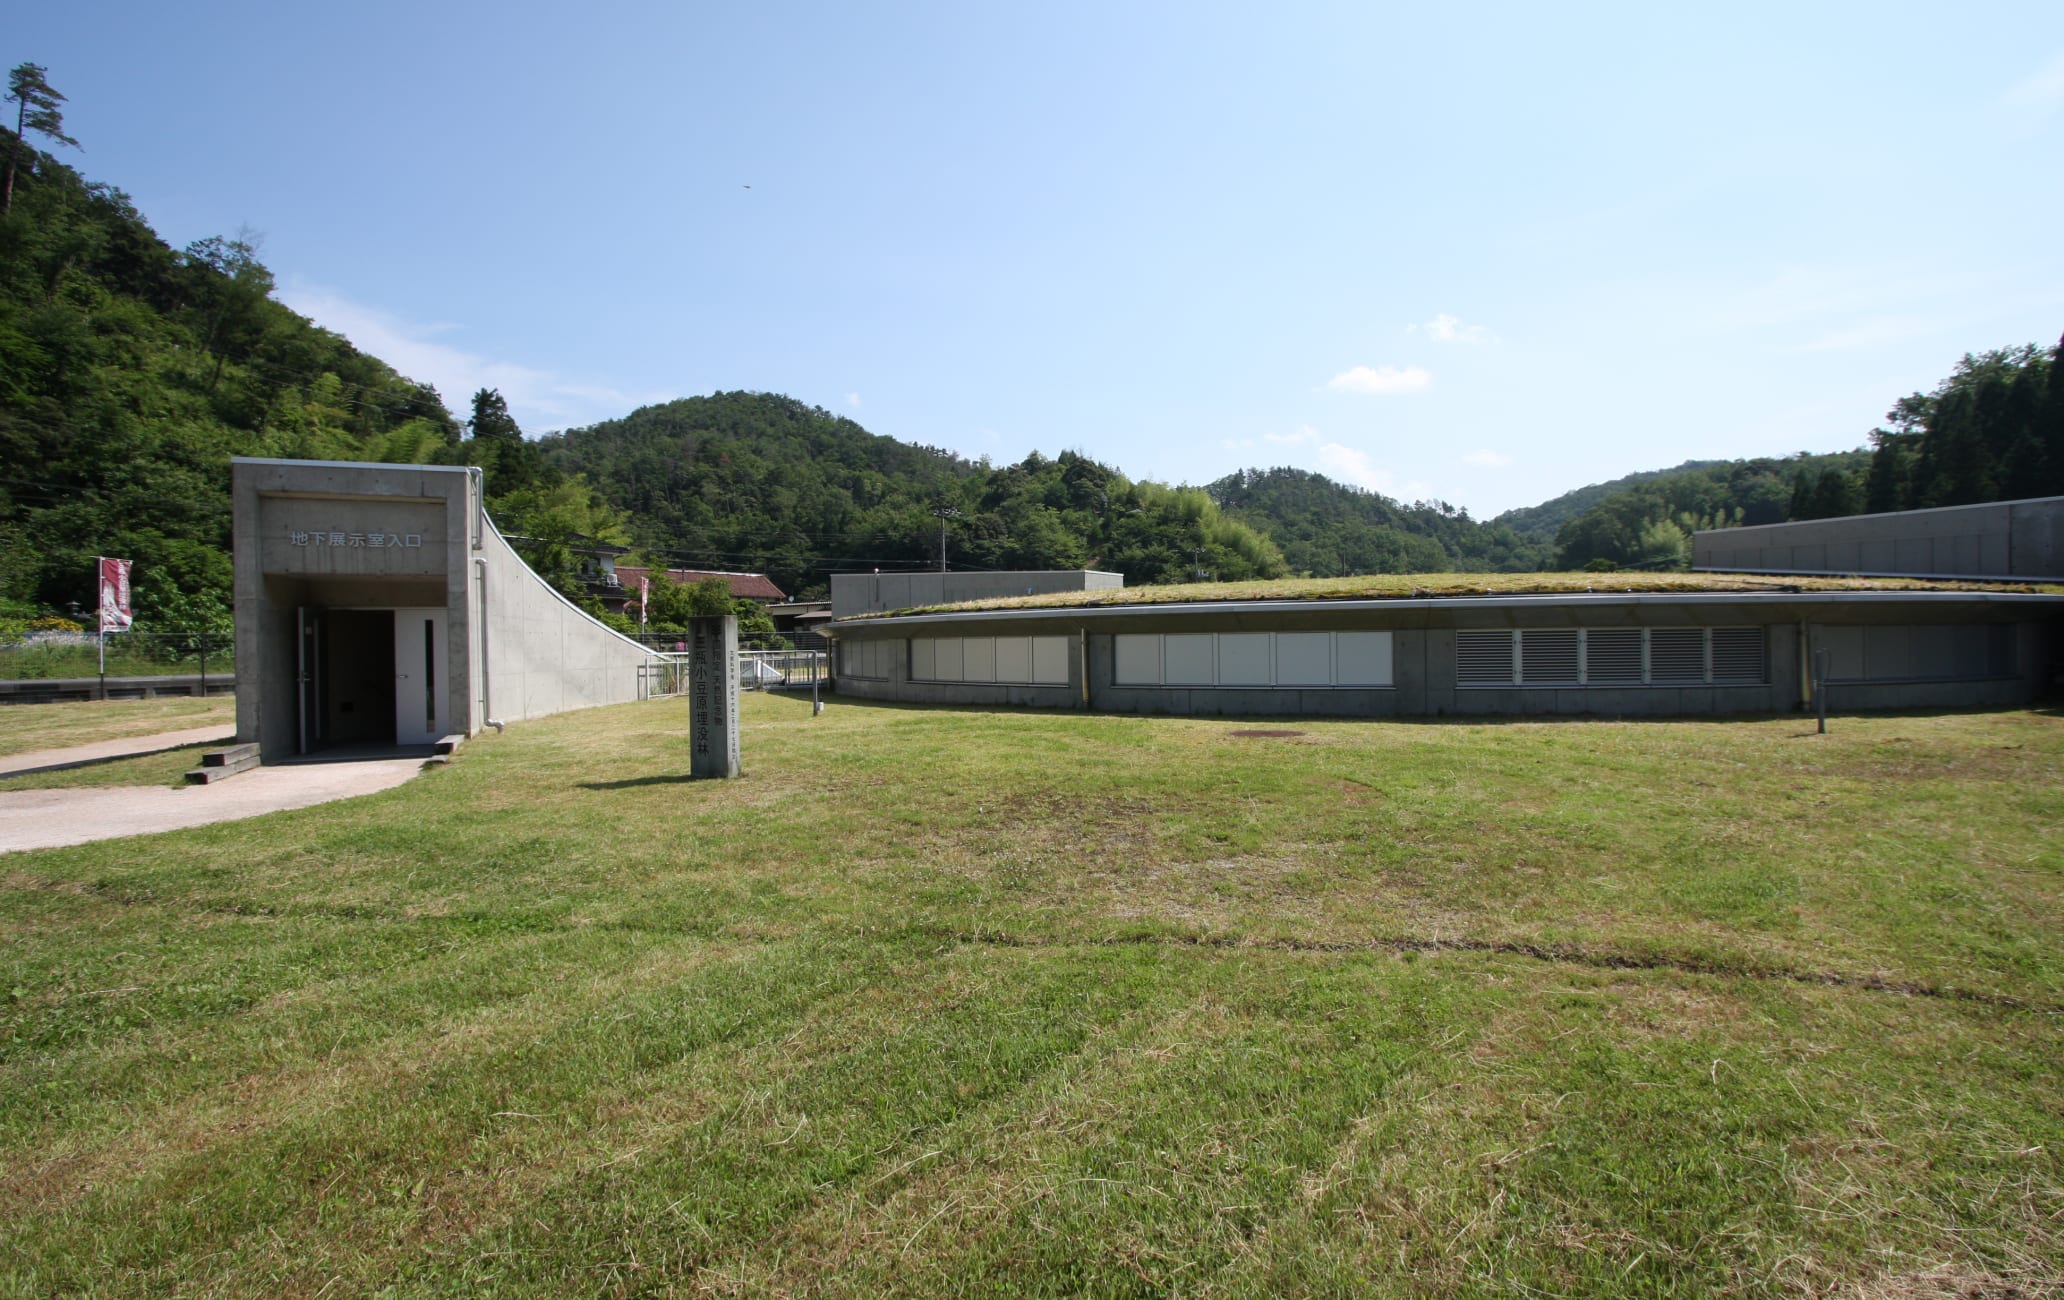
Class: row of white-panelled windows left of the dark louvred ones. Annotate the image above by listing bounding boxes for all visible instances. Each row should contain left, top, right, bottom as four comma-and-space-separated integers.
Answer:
1117, 631, 1391, 687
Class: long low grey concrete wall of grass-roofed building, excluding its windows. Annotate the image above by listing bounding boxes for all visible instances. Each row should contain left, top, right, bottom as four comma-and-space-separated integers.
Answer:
834, 592, 2064, 718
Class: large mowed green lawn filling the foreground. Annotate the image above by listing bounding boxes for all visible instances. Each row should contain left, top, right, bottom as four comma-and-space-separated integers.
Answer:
0, 695, 2064, 1296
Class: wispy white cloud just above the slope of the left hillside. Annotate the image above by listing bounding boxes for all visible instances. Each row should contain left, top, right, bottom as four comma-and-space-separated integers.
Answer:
279, 279, 671, 433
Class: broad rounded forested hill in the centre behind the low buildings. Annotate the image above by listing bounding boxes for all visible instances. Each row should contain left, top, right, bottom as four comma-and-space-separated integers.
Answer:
541, 392, 1286, 592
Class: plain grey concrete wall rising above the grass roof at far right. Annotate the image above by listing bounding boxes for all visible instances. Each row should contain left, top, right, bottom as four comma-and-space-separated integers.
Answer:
1692, 497, 2064, 580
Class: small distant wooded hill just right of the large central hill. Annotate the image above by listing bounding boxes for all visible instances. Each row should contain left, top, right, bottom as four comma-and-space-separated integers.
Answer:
1207, 468, 1552, 578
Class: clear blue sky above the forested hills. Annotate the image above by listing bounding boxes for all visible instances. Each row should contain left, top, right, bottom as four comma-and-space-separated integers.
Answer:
16, 0, 2064, 518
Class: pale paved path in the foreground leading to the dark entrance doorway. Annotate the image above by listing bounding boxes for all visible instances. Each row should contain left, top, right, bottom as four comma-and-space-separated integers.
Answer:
0, 755, 423, 852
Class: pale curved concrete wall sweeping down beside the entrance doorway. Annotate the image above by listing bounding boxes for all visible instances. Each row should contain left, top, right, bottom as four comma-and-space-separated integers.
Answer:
475, 520, 658, 722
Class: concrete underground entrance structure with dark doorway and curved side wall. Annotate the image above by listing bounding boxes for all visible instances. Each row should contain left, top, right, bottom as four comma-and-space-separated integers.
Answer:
231, 458, 654, 761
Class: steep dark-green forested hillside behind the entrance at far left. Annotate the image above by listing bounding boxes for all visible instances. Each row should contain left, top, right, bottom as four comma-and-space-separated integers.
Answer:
0, 130, 458, 629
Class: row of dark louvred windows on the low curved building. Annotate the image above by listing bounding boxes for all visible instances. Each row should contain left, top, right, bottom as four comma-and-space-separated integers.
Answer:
1455, 627, 1769, 687
